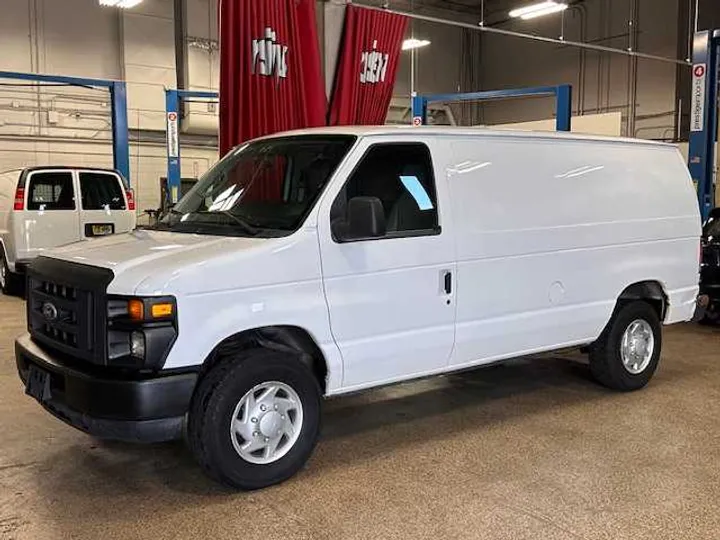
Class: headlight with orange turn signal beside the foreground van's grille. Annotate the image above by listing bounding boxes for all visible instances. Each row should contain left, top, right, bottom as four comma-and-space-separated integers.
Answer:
107, 296, 178, 369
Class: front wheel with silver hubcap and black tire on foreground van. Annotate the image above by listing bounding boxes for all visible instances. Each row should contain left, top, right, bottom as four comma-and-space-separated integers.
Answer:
188, 349, 320, 489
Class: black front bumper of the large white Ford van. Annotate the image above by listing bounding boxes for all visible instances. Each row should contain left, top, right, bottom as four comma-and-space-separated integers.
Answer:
15, 334, 197, 442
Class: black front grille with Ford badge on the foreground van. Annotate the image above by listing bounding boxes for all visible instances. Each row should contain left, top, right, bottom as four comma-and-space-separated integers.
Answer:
27, 257, 112, 364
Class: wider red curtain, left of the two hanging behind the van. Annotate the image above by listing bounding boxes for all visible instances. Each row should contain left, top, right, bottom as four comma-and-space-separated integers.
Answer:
220, 0, 327, 155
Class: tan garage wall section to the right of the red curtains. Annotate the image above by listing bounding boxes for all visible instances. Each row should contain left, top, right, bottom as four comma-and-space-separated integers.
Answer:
352, 0, 696, 135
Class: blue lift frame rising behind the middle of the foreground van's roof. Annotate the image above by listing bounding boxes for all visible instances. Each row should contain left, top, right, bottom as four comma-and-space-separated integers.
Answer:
412, 84, 572, 131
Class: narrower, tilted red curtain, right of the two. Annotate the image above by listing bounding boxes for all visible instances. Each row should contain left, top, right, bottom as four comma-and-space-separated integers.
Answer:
330, 4, 408, 125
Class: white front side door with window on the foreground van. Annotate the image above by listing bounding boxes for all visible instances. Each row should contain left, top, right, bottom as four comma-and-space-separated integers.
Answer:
318, 142, 455, 390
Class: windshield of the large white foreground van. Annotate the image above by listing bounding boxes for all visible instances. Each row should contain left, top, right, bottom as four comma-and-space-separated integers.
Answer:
156, 136, 355, 236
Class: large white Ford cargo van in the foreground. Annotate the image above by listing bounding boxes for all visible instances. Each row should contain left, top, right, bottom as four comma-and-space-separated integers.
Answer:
16, 127, 701, 488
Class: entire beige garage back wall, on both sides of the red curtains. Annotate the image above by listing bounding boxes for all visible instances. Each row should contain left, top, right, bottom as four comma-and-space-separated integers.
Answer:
0, 0, 708, 214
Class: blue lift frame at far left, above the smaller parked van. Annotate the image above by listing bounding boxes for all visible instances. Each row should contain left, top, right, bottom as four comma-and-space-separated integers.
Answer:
0, 71, 130, 184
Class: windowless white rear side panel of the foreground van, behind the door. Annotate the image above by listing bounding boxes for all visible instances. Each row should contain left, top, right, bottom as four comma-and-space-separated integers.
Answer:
448, 136, 700, 365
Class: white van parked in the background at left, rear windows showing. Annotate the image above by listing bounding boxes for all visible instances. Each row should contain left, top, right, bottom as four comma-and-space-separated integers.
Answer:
0, 167, 136, 293
